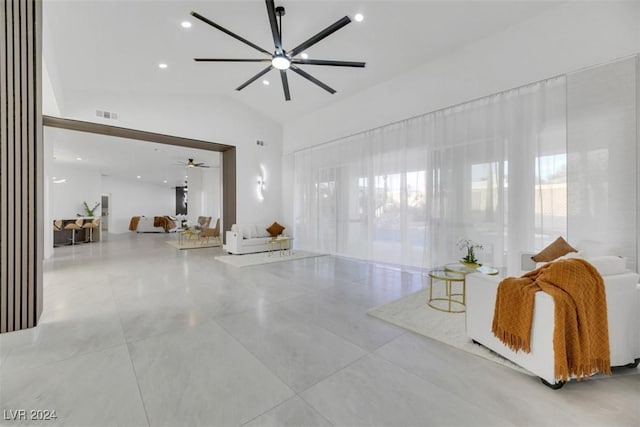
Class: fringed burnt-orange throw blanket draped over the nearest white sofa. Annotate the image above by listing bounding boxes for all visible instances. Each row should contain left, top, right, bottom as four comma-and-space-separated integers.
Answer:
492, 258, 611, 381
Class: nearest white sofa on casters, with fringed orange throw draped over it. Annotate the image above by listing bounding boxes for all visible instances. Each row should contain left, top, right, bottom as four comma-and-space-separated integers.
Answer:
466, 252, 640, 389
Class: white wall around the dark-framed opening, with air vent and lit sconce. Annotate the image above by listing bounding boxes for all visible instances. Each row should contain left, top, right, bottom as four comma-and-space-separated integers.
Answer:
55, 93, 282, 229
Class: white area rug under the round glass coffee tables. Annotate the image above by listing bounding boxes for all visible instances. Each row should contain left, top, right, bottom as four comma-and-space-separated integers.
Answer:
367, 289, 533, 375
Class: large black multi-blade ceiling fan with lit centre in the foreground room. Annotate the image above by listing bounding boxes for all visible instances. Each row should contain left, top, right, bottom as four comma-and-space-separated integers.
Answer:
191, 0, 365, 101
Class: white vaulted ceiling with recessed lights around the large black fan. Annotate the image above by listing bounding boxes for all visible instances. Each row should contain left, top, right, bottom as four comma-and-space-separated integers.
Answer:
43, 0, 557, 123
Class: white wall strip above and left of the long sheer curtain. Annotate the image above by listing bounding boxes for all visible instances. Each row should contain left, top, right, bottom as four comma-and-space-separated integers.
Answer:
282, 2, 640, 237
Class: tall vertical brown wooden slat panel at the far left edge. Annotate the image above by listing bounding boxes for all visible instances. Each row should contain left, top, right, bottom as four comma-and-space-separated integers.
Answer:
0, 0, 43, 332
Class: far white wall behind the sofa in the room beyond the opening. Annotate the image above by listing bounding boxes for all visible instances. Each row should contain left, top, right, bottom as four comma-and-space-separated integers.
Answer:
104, 176, 176, 233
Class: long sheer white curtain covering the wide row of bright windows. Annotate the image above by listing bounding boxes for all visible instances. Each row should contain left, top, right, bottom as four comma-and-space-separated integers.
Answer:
294, 78, 567, 271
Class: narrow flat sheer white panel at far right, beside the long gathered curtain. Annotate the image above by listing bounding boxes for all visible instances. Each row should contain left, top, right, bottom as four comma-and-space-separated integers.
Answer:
567, 55, 640, 271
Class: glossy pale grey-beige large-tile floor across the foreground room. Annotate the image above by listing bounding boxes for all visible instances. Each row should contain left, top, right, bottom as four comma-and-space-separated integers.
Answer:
0, 234, 640, 426
